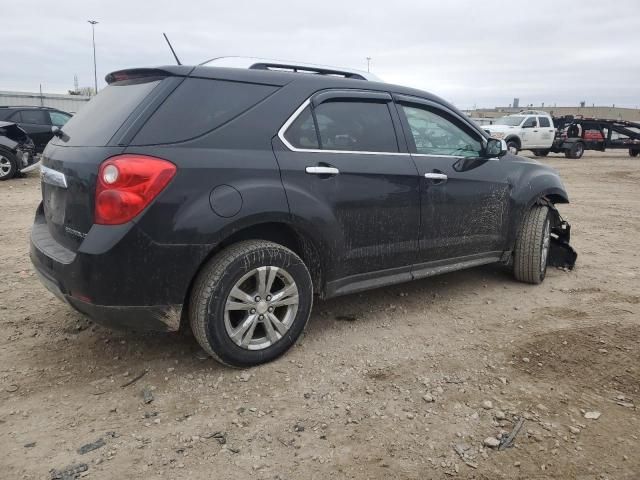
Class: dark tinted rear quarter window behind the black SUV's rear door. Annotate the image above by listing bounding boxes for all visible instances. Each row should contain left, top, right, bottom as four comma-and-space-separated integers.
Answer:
131, 78, 279, 145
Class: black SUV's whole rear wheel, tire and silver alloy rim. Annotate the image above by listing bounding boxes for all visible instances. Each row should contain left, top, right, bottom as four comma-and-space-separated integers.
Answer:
189, 240, 313, 367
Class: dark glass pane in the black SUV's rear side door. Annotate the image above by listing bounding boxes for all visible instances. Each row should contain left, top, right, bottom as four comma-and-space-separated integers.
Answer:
315, 101, 398, 153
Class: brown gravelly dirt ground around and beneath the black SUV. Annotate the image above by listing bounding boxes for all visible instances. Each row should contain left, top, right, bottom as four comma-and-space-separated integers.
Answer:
0, 152, 640, 479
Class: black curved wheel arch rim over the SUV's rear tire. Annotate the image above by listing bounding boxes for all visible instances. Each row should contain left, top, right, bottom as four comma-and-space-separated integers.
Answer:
181, 221, 325, 328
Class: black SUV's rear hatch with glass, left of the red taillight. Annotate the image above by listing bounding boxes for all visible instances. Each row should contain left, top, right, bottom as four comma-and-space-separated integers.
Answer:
36, 71, 188, 251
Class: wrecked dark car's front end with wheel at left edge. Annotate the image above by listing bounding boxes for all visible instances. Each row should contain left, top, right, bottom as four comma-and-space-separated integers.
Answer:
0, 121, 36, 181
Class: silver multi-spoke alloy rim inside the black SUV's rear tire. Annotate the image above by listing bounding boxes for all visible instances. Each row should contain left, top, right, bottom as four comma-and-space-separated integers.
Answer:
224, 266, 299, 350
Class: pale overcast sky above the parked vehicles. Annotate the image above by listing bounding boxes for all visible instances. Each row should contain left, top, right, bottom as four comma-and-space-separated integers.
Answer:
0, 0, 640, 108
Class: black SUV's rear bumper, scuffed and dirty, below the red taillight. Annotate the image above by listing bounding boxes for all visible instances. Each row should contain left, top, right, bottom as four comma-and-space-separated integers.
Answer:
30, 208, 205, 331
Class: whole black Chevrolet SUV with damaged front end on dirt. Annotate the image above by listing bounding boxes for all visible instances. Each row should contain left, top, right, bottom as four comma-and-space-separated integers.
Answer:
31, 64, 575, 366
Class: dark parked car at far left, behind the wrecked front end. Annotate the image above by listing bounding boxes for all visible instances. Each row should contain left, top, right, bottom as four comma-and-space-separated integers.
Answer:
0, 107, 71, 153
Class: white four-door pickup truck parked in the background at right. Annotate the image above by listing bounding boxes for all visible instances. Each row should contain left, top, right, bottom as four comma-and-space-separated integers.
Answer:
482, 110, 556, 156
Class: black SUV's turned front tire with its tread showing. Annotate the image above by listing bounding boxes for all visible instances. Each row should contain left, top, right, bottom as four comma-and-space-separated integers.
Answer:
513, 205, 551, 284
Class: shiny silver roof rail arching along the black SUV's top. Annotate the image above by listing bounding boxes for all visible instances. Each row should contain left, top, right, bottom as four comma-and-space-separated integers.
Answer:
200, 57, 382, 82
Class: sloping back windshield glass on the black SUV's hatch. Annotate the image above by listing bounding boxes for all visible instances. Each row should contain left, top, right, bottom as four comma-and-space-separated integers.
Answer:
55, 77, 160, 147
